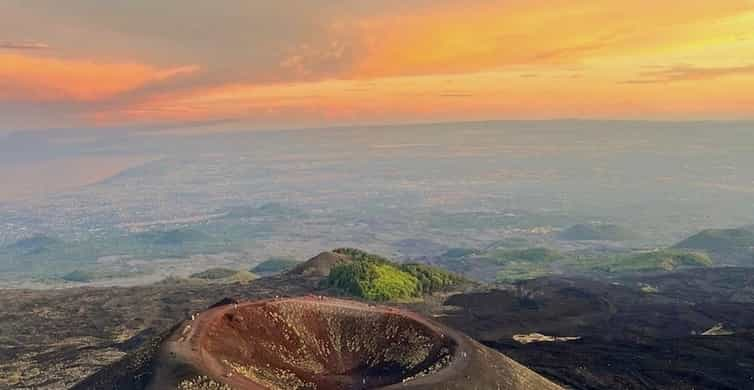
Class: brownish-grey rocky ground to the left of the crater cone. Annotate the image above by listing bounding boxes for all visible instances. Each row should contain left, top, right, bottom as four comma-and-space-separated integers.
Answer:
0, 277, 313, 389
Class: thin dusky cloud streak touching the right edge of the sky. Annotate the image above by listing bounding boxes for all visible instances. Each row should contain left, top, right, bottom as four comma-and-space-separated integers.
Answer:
625, 64, 754, 84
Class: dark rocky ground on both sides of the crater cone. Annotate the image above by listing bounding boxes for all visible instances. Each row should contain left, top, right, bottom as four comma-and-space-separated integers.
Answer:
0, 268, 754, 389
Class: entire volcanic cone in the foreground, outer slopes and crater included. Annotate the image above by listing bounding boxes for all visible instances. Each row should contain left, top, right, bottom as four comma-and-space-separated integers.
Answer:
74, 296, 561, 390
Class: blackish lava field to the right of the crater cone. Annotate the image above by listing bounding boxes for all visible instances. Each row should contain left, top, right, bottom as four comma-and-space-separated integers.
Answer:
443, 269, 754, 390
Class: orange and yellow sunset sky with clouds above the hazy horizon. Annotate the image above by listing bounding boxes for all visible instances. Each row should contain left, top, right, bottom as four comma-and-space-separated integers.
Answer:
0, 0, 754, 130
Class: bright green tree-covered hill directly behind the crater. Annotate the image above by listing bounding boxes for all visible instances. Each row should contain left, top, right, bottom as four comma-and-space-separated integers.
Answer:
323, 248, 463, 301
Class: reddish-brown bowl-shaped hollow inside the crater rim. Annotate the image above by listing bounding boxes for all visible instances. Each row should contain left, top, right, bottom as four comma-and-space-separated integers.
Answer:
200, 298, 458, 390
